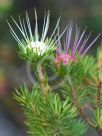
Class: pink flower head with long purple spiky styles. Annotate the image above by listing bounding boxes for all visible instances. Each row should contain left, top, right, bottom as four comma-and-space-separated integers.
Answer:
54, 23, 100, 65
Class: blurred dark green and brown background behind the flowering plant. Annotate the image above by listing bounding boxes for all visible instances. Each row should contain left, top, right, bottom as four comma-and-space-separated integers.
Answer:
0, 0, 102, 136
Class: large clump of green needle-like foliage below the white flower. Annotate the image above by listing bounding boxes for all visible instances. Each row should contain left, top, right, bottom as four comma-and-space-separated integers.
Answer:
14, 85, 87, 136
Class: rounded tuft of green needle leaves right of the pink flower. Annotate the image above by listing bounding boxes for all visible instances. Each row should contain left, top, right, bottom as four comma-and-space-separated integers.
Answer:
70, 56, 96, 85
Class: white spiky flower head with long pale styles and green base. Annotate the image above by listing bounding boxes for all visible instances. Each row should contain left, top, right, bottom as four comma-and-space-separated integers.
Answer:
7, 10, 67, 56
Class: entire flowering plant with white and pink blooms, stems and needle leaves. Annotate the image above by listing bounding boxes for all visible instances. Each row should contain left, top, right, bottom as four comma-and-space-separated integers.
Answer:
8, 10, 102, 136
